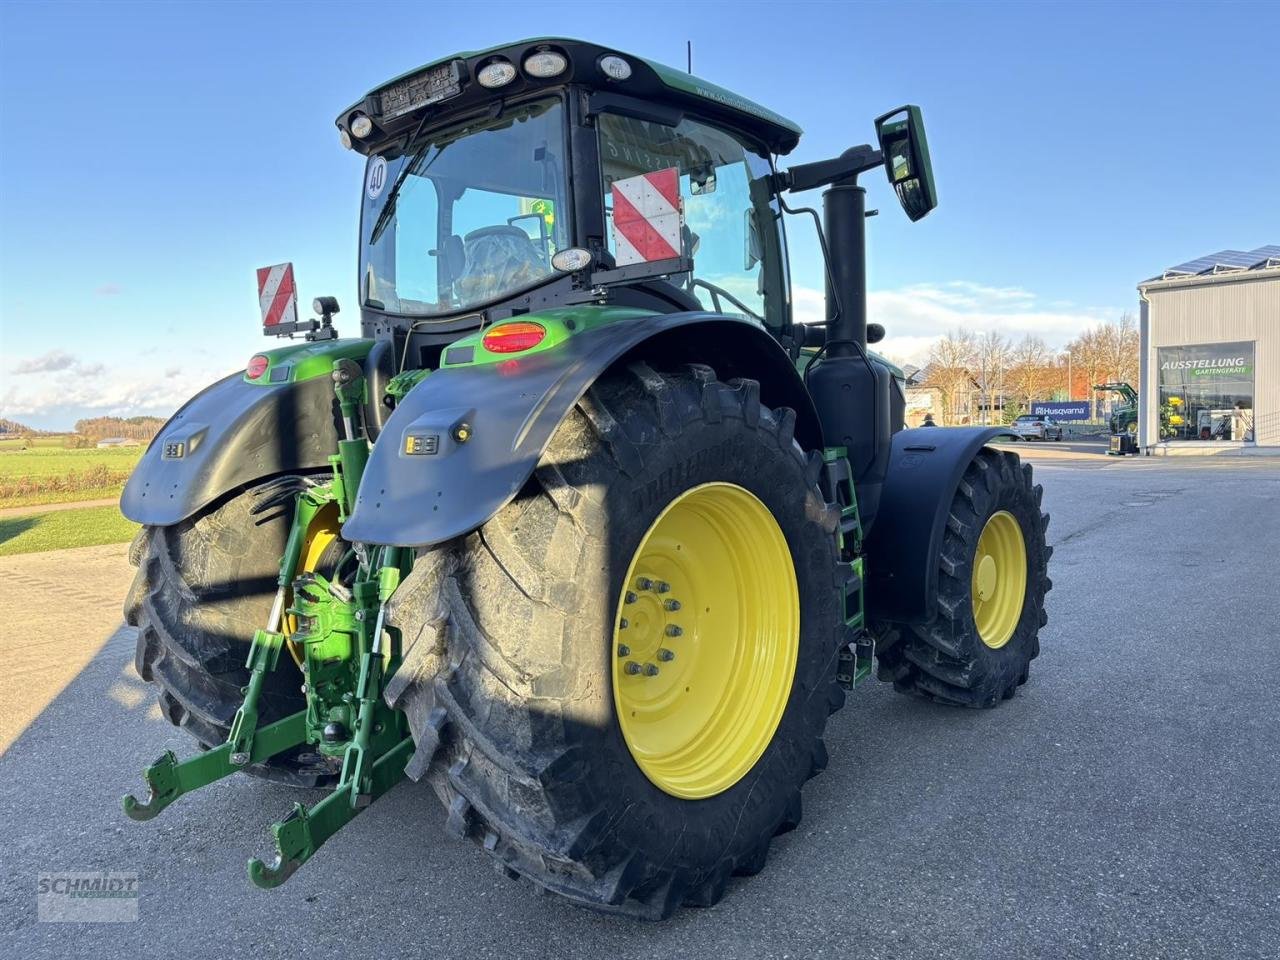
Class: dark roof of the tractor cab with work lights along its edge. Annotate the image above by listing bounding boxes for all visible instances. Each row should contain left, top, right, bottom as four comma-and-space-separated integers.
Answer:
337, 37, 803, 154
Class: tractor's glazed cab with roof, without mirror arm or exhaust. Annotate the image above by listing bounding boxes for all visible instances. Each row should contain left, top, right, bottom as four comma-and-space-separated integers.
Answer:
338, 40, 800, 366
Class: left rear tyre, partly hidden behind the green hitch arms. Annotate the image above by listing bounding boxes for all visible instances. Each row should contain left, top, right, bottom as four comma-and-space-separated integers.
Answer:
124, 493, 332, 787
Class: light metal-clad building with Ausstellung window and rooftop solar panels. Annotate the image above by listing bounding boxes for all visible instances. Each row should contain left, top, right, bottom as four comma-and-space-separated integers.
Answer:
1138, 246, 1280, 456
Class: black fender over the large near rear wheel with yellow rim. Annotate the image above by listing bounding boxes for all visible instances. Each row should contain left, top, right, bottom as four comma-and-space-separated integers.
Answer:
342, 311, 822, 547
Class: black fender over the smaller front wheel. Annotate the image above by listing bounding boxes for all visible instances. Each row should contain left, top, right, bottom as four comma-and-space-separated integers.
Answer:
864, 426, 1012, 623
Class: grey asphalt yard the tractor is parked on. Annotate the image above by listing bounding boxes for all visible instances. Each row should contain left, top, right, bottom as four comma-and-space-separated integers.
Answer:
0, 444, 1280, 960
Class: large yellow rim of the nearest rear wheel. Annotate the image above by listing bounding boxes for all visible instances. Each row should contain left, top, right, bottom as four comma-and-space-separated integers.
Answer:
612, 483, 800, 800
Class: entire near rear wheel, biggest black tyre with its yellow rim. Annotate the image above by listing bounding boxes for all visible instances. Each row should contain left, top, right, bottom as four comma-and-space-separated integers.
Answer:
387, 365, 849, 918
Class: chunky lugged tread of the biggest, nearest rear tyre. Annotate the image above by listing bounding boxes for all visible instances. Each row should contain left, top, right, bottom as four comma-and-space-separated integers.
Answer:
388, 364, 846, 919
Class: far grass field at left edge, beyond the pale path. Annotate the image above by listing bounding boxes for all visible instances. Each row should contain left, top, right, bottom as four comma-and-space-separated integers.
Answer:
0, 442, 143, 507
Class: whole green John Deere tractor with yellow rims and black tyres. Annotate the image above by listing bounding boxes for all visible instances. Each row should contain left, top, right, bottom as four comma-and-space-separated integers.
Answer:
122, 40, 1051, 918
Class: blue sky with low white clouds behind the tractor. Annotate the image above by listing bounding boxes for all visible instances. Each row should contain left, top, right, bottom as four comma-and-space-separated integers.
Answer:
0, 0, 1280, 428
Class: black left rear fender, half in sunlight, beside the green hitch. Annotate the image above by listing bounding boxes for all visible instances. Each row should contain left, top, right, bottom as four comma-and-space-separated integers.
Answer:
120, 372, 338, 526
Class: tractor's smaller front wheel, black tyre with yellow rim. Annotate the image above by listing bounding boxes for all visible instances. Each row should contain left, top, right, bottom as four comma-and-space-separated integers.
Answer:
873, 447, 1053, 707
